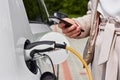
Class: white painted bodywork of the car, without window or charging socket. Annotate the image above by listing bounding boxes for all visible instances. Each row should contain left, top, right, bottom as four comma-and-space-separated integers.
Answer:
0, 0, 51, 80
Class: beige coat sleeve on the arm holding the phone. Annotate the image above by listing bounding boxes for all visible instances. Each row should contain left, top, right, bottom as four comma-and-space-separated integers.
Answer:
73, 1, 92, 38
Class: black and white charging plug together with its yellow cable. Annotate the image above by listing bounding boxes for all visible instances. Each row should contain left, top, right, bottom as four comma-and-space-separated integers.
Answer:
25, 41, 92, 80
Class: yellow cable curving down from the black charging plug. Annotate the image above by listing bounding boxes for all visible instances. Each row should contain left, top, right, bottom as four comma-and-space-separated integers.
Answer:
66, 46, 92, 80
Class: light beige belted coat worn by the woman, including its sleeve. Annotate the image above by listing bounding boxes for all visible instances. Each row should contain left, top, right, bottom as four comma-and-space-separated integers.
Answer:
75, 0, 120, 80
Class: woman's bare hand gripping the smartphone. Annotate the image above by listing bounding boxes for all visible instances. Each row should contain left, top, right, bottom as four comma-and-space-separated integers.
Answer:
58, 18, 81, 38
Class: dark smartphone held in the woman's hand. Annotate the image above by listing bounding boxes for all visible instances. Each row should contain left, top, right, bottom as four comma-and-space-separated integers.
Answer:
49, 16, 84, 32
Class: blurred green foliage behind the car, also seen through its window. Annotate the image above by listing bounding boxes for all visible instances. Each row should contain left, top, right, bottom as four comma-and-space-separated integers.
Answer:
24, 0, 88, 19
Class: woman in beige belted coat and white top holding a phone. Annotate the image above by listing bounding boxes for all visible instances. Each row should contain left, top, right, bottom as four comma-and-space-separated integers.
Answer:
59, 0, 120, 80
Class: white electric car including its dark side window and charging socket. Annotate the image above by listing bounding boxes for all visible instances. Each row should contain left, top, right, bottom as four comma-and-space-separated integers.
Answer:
0, 0, 69, 80
